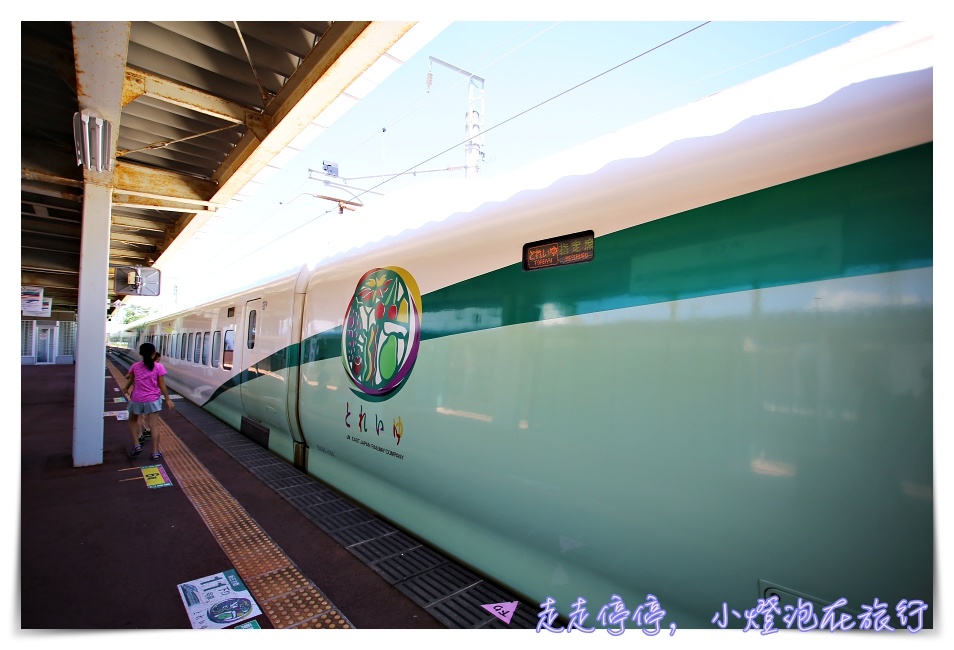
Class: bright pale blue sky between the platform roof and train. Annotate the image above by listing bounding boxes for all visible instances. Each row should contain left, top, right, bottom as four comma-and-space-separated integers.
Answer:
163, 20, 889, 307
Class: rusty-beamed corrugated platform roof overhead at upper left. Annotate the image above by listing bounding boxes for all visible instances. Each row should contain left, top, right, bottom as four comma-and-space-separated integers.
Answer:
20, 21, 433, 312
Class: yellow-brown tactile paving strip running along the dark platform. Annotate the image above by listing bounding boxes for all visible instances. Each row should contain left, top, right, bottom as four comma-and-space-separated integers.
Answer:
107, 362, 352, 630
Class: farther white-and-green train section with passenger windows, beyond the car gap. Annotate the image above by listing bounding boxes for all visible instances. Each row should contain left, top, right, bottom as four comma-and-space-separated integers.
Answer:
115, 268, 308, 466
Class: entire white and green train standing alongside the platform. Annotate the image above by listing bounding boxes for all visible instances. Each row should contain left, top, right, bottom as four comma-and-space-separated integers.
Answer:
113, 25, 934, 634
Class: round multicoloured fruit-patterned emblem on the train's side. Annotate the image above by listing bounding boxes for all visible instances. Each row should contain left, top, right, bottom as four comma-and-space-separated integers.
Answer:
341, 266, 421, 397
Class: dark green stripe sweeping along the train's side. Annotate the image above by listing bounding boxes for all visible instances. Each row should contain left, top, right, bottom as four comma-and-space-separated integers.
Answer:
199, 143, 933, 401
